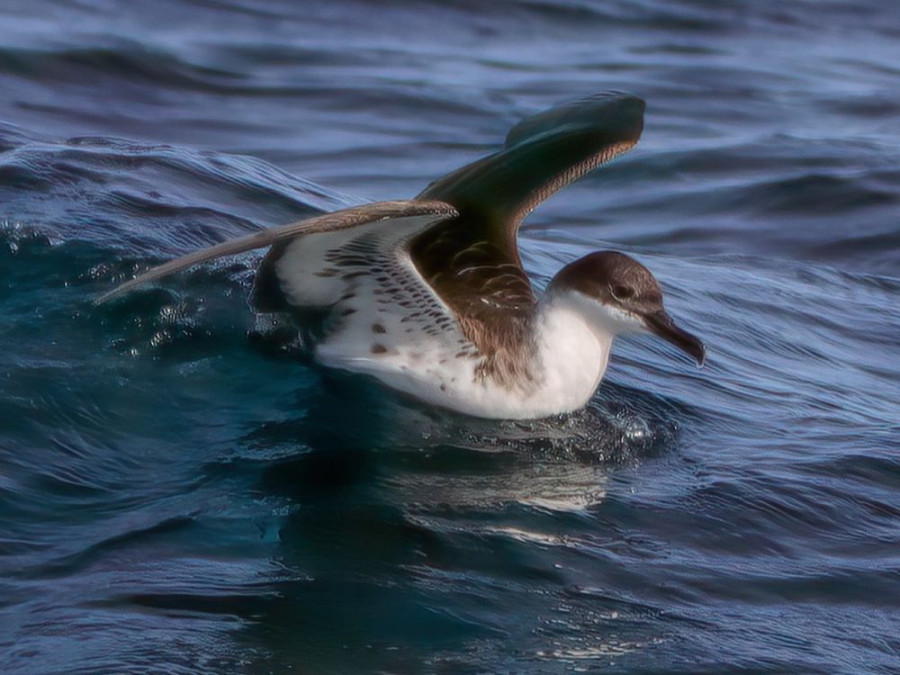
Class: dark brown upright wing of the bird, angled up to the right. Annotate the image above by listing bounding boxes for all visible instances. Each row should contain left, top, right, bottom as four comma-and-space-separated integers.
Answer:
410, 92, 644, 360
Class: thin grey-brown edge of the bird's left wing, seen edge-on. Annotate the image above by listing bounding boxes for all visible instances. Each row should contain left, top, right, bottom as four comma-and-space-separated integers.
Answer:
94, 201, 457, 304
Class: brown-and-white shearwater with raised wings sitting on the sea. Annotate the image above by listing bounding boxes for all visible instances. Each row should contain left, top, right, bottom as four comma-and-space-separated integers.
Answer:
97, 92, 705, 419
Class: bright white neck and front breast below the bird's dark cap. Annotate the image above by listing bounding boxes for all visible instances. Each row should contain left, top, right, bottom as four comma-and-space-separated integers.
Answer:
534, 285, 615, 412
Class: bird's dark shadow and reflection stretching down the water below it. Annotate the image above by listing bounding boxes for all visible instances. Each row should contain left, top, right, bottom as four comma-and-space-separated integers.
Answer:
214, 376, 692, 672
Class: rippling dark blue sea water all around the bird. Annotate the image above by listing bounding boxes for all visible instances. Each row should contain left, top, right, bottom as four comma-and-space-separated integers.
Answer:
0, 0, 900, 673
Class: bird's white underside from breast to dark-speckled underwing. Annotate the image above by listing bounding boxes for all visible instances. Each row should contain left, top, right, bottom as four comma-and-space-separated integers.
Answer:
276, 218, 612, 419
